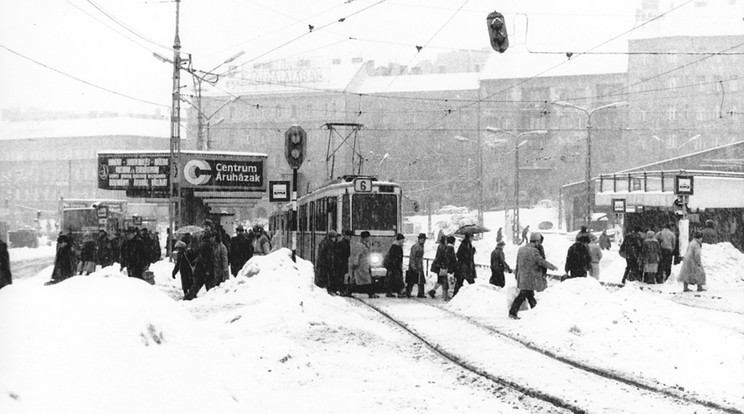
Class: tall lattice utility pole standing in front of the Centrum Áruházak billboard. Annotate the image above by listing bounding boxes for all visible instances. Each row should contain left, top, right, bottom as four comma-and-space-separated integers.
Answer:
167, 0, 181, 257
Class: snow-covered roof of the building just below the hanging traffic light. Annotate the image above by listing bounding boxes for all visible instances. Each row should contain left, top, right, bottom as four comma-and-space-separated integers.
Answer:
481, 45, 628, 80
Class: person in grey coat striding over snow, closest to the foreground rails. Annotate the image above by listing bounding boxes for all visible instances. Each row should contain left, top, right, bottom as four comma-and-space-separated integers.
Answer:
509, 233, 558, 319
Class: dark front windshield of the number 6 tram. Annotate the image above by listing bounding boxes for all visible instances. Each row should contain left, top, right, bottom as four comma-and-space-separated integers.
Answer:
352, 194, 398, 230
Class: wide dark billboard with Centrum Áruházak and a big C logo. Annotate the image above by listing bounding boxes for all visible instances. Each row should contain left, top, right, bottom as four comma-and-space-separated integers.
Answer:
98, 151, 267, 195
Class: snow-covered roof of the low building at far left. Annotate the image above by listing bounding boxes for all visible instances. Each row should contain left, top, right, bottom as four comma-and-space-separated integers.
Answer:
0, 117, 170, 140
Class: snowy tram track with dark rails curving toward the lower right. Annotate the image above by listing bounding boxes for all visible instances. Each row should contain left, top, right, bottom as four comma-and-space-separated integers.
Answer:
356, 298, 742, 413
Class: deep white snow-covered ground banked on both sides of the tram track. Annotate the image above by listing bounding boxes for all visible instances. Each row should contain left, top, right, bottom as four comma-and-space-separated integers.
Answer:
0, 205, 744, 413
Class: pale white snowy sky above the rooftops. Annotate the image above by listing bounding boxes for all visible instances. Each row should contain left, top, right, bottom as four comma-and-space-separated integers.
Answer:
0, 0, 636, 114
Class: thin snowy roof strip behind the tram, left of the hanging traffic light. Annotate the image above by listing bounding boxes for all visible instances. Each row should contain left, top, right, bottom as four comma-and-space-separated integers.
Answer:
353, 72, 480, 94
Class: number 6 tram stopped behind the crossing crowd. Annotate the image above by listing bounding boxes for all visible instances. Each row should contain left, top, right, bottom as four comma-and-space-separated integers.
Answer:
269, 176, 402, 284
